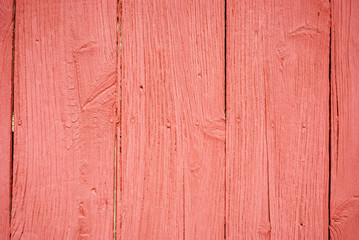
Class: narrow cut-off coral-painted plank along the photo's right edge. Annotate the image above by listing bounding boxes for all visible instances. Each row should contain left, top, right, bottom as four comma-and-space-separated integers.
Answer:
330, 0, 359, 239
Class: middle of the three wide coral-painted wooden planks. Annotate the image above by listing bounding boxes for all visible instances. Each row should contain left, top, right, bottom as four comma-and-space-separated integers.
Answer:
117, 0, 225, 239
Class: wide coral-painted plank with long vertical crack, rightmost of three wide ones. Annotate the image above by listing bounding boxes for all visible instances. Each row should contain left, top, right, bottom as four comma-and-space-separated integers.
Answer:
226, 0, 330, 239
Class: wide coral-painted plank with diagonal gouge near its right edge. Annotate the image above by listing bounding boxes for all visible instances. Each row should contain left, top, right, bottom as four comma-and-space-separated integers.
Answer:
11, 0, 117, 239
